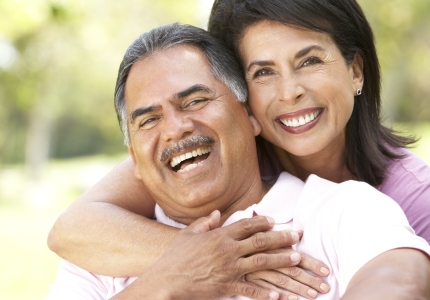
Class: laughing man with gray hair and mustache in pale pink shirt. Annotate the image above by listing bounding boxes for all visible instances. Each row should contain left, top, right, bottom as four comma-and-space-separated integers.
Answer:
48, 25, 430, 299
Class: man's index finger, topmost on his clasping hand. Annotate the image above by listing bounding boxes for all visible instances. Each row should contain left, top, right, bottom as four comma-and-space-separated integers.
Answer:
223, 216, 275, 240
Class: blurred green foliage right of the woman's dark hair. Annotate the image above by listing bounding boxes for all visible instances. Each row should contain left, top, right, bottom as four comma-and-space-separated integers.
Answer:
358, 0, 430, 123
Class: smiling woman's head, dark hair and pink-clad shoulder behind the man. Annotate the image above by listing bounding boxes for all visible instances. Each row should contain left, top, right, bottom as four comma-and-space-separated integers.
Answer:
205, 1, 430, 242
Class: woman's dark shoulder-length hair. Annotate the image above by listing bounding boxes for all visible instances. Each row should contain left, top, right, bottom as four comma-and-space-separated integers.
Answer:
208, 0, 415, 186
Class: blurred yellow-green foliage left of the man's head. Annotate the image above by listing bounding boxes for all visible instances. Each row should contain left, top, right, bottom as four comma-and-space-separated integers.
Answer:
0, 0, 208, 171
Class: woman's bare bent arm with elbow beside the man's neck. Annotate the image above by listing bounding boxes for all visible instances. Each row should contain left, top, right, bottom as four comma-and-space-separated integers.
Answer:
48, 158, 178, 277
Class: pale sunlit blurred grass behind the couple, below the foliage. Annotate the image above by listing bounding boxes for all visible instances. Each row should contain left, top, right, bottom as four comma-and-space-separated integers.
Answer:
0, 123, 430, 300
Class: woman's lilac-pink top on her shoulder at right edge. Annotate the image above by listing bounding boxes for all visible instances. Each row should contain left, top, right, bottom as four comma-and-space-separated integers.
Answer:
259, 143, 430, 243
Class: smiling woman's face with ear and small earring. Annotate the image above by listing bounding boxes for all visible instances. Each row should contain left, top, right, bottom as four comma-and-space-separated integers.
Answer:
239, 21, 363, 156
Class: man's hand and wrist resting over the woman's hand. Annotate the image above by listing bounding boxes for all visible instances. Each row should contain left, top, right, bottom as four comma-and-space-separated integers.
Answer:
112, 211, 301, 299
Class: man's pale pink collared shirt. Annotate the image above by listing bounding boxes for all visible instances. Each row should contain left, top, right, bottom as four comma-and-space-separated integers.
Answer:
47, 173, 430, 300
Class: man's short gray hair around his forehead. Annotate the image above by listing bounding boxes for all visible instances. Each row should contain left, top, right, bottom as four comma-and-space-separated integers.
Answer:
115, 23, 248, 146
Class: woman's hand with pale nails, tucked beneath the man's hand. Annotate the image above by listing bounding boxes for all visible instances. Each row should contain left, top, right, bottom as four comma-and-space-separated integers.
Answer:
246, 249, 330, 300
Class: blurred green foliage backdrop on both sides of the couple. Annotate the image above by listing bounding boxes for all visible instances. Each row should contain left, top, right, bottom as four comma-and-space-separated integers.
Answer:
0, 0, 430, 171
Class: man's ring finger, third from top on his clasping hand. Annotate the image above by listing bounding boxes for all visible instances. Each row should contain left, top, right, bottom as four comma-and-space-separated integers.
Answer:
236, 250, 300, 274
